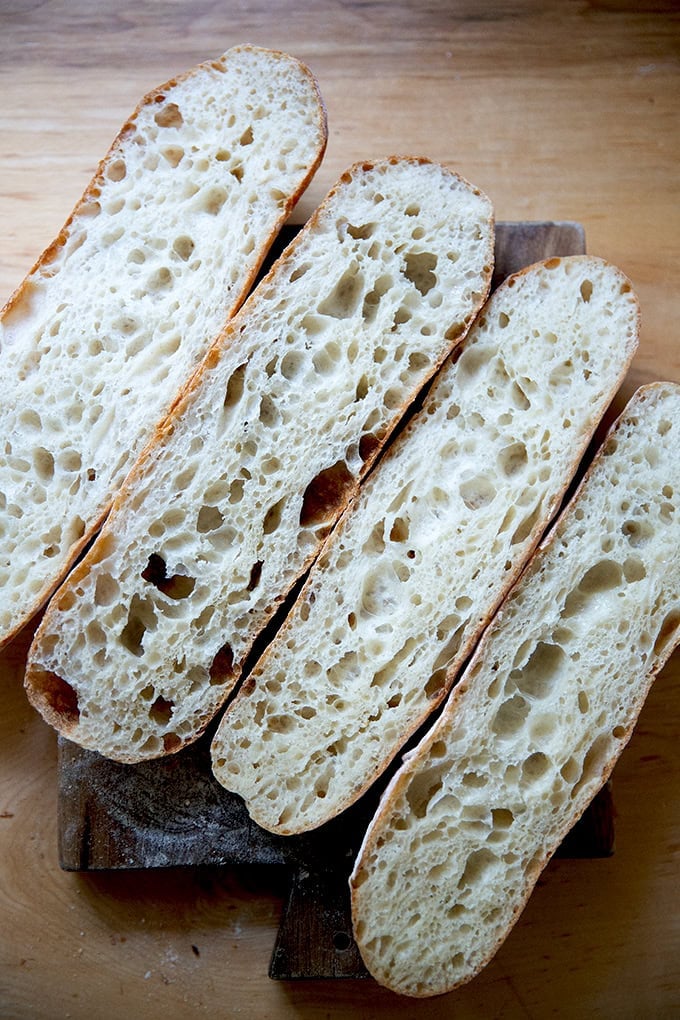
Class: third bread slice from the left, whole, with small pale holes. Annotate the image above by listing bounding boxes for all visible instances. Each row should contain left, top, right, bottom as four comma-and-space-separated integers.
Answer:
212, 256, 638, 834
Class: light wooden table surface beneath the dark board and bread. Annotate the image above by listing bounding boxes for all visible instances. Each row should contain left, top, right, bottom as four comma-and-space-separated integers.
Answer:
0, 0, 680, 1020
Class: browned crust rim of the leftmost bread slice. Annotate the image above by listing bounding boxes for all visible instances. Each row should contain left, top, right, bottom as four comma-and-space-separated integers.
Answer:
0, 45, 328, 650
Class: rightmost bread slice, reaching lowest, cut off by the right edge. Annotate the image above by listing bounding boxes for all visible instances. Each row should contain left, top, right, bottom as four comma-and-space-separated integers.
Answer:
351, 384, 680, 996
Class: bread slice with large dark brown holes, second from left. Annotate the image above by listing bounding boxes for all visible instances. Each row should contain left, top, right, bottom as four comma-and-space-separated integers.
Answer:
27, 158, 493, 762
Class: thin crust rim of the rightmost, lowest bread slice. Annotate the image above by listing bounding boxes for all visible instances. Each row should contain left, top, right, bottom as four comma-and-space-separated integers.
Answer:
349, 383, 680, 999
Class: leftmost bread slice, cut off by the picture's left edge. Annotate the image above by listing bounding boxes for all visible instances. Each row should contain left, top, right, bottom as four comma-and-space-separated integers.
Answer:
0, 46, 326, 645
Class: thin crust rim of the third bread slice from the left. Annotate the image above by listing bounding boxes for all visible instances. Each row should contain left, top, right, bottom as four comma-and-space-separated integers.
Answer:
225, 255, 640, 835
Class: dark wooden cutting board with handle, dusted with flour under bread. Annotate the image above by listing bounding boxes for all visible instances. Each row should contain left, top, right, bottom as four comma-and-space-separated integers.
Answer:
58, 221, 614, 978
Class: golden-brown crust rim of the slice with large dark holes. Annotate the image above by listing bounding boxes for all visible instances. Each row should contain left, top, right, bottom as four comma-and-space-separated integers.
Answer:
23, 155, 494, 750
